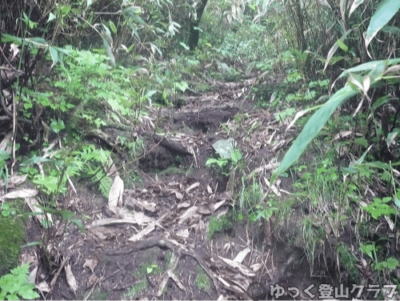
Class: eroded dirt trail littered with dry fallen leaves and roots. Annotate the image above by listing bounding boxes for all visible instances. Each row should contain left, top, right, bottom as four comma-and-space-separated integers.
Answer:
28, 79, 331, 301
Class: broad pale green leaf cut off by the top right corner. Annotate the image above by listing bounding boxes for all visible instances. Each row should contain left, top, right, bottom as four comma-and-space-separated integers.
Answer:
365, 0, 400, 48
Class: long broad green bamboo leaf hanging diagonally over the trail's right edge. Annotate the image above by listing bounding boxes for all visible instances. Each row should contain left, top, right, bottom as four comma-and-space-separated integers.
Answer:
271, 86, 357, 184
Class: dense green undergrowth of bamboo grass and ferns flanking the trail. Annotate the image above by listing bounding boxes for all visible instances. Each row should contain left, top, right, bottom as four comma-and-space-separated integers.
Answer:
0, 0, 400, 300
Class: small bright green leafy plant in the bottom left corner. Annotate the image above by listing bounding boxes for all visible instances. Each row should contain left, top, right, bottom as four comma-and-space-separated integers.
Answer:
0, 264, 40, 300
